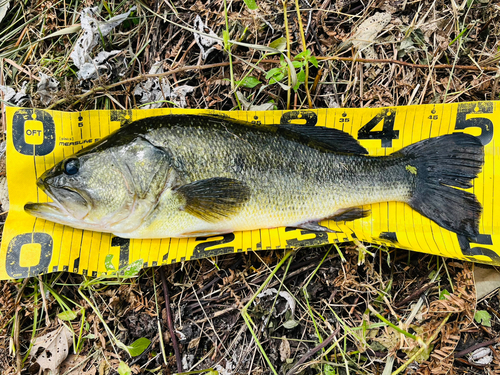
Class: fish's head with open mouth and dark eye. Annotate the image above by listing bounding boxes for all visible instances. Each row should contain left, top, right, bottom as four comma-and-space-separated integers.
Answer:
24, 150, 135, 232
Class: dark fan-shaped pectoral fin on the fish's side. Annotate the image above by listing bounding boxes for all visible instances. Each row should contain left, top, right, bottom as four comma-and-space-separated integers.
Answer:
177, 177, 250, 222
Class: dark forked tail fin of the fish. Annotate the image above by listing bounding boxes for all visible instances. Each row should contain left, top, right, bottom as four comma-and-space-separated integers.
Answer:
399, 133, 484, 237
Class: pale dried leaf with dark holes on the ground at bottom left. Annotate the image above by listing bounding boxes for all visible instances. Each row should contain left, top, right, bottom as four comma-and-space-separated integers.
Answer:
30, 324, 73, 374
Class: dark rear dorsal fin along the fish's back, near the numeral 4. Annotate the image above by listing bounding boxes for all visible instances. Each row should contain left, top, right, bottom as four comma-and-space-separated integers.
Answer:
278, 125, 368, 155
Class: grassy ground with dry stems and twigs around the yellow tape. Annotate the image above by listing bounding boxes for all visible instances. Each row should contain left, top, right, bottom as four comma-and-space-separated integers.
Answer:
0, 0, 500, 374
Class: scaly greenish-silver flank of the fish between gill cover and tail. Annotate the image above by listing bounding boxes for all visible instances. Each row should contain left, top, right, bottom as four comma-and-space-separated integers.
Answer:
131, 118, 414, 235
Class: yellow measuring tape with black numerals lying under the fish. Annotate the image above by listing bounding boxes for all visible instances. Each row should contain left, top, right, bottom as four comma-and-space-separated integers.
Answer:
0, 102, 500, 279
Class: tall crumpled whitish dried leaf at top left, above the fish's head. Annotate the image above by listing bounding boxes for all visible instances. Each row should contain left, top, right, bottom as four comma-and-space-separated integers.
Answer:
70, 6, 136, 78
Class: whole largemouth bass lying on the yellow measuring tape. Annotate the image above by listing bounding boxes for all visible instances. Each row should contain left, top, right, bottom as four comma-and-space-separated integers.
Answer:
24, 114, 484, 239
